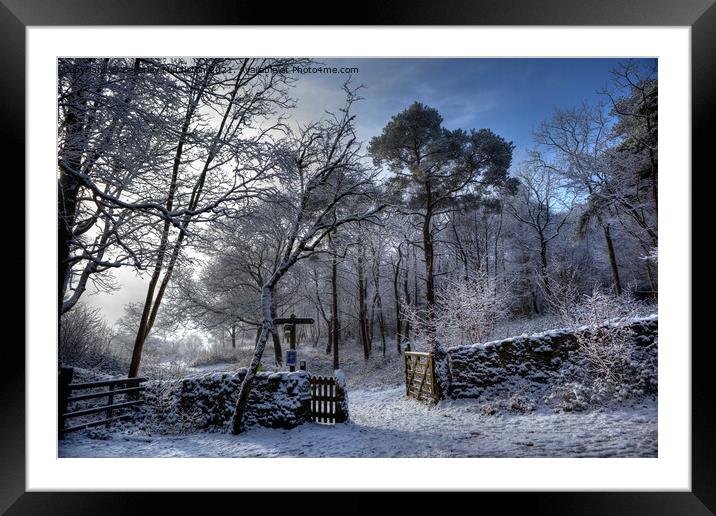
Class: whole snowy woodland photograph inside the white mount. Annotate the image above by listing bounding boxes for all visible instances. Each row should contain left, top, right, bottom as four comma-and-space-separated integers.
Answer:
58, 57, 656, 458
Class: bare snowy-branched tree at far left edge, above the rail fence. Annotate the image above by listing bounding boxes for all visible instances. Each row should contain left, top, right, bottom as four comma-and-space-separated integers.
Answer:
57, 58, 183, 313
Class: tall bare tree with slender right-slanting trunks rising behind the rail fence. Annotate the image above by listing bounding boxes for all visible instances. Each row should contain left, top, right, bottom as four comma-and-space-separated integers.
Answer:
129, 59, 300, 377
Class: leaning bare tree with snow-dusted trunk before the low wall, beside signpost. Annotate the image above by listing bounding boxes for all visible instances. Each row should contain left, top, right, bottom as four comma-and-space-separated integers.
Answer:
231, 86, 383, 433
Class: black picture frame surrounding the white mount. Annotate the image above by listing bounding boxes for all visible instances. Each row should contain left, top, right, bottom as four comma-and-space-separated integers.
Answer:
0, 0, 716, 514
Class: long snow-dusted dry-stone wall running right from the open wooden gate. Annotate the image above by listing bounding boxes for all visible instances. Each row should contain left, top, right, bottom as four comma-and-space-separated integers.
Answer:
448, 315, 658, 398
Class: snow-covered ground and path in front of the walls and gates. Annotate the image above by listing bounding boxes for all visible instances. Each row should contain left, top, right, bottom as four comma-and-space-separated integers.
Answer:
59, 387, 657, 457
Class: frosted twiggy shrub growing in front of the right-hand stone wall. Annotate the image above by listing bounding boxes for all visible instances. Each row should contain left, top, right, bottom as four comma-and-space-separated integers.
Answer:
558, 286, 639, 395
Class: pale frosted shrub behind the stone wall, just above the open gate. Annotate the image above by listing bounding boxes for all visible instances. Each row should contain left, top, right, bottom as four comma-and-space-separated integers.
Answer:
405, 274, 509, 347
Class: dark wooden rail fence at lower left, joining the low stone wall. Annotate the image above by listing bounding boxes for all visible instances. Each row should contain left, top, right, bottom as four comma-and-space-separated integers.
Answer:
57, 367, 147, 437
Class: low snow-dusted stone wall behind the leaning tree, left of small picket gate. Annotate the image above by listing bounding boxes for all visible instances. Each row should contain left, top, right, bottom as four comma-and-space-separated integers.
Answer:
134, 368, 311, 432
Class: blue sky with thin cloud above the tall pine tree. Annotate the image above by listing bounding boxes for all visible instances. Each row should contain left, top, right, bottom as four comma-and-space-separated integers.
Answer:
293, 58, 656, 162
